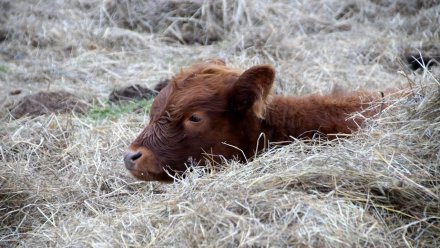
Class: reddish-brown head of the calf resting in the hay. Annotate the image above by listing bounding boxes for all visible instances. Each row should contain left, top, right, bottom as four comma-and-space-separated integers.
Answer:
124, 60, 275, 181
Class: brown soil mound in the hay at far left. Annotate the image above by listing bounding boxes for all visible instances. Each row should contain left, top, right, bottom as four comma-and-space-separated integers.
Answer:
10, 91, 87, 118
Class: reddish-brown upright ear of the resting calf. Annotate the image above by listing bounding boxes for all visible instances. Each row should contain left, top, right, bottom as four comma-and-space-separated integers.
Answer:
228, 65, 275, 118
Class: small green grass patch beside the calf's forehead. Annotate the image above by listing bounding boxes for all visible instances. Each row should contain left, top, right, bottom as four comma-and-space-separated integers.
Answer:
85, 99, 153, 121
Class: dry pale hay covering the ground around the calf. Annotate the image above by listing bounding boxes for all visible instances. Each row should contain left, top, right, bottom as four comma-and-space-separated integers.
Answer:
0, 0, 440, 247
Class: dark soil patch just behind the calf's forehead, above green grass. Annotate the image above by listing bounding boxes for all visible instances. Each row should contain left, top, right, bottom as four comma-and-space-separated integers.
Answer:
108, 84, 157, 103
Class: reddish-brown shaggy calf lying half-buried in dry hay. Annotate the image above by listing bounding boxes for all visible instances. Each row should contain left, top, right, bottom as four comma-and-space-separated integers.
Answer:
124, 60, 380, 181
